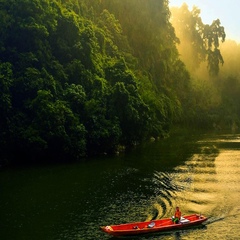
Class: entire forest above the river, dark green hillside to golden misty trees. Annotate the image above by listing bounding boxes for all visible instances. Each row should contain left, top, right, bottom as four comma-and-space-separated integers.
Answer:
0, 0, 240, 165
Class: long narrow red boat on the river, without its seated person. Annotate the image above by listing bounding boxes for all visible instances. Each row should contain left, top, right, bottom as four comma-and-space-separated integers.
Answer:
100, 214, 207, 236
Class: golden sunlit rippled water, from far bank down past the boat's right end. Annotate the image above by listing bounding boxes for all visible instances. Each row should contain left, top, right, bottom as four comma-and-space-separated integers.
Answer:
150, 136, 240, 240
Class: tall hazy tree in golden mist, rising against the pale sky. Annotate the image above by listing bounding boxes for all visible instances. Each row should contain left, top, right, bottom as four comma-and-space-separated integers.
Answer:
171, 3, 226, 76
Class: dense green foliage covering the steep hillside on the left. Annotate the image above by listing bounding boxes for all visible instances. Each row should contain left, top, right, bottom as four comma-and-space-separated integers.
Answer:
0, 0, 188, 161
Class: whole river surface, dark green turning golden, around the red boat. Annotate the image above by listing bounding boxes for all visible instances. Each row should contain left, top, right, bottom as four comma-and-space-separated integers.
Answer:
0, 134, 240, 240
